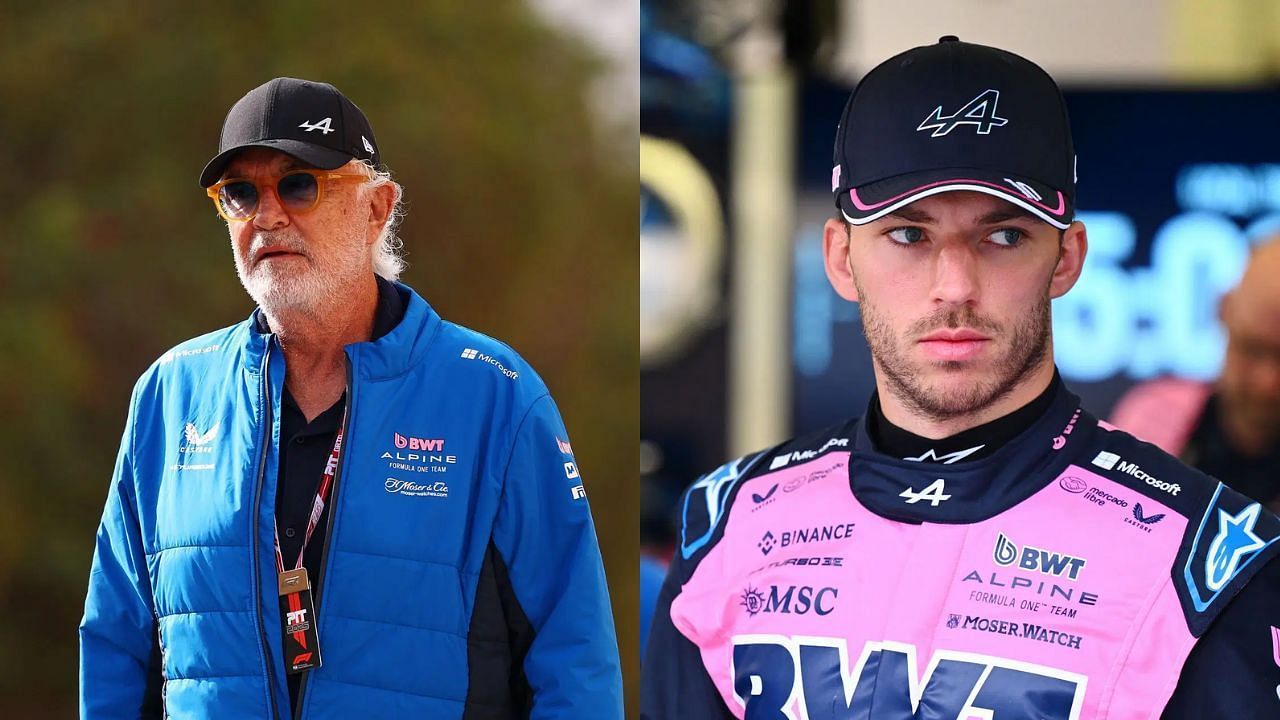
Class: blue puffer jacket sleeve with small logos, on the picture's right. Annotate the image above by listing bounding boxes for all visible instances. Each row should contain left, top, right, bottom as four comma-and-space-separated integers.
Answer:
493, 395, 622, 720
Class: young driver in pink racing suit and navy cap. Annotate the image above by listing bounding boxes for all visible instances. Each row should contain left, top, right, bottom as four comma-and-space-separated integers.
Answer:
641, 37, 1280, 720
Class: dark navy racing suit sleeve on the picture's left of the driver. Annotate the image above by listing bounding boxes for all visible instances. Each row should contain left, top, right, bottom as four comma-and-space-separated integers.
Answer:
640, 550, 733, 720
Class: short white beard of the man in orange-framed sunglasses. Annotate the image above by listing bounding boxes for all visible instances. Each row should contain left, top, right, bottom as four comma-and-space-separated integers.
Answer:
236, 228, 371, 318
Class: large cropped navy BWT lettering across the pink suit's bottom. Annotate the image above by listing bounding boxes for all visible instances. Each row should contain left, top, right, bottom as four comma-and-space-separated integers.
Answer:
730, 634, 1088, 720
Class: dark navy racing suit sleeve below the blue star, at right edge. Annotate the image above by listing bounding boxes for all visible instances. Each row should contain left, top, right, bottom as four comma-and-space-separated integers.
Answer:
1161, 550, 1280, 720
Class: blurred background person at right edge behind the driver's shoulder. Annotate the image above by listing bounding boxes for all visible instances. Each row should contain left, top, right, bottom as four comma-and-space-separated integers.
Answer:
1111, 237, 1280, 511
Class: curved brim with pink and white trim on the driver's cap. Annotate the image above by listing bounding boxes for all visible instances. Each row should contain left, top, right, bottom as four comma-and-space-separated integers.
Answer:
836, 168, 1075, 229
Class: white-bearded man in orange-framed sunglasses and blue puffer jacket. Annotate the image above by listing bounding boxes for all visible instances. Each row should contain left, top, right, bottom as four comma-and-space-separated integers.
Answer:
81, 78, 622, 719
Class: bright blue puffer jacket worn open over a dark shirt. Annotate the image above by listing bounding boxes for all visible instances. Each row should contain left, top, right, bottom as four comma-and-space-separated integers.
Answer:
79, 286, 622, 720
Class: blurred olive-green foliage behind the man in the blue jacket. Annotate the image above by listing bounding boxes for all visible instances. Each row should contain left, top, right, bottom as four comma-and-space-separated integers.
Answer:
0, 0, 639, 717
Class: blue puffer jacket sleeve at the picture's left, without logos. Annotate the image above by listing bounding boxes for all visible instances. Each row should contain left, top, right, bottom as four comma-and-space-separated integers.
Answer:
79, 392, 161, 720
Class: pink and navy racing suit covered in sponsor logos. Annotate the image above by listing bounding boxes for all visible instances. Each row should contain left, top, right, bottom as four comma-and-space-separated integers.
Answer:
641, 379, 1280, 720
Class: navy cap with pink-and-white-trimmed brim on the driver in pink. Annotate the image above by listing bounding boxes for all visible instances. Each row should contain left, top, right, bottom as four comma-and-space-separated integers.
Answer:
831, 35, 1075, 228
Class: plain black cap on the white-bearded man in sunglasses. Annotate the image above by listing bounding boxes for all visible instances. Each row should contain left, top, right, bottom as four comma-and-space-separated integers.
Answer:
200, 77, 381, 187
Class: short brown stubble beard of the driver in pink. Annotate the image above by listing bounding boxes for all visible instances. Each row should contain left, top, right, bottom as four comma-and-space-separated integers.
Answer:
855, 274, 1052, 421
